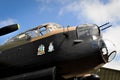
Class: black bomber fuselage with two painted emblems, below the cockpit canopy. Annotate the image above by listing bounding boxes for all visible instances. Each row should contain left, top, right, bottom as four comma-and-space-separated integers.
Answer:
0, 25, 113, 78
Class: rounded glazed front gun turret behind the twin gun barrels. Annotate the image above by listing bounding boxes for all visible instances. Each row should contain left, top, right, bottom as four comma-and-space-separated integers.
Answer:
77, 24, 101, 40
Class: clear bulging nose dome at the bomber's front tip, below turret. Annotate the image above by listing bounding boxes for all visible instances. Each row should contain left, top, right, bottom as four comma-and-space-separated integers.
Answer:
101, 40, 117, 62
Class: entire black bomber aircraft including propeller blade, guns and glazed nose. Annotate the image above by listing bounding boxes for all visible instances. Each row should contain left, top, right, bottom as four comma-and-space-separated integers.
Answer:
0, 23, 116, 80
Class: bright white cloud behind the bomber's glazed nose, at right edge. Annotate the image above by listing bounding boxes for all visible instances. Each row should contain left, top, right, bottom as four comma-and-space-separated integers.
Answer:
103, 25, 120, 70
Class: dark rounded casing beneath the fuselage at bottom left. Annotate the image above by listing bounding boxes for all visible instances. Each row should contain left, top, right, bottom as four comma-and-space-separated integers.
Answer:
0, 67, 56, 80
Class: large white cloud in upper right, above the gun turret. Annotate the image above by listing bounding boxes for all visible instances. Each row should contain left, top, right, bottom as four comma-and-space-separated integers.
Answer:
59, 0, 120, 24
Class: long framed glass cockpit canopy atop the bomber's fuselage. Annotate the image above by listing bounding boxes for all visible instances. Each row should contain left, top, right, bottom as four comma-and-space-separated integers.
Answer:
6, 23, 61, 43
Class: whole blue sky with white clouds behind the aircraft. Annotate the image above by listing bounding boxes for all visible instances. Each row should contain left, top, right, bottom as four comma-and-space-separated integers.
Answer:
0, 0, 120, 70
